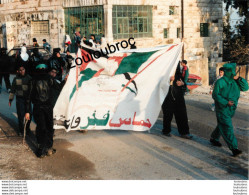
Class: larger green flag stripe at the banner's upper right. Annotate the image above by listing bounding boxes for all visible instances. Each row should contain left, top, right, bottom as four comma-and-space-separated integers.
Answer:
115, 51, 157, 75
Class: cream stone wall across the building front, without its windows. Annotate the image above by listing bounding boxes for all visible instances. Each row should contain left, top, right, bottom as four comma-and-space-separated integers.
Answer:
0, 0, 223, 85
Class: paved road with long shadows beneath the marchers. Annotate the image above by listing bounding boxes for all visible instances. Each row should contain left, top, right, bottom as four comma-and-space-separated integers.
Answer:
0, 78, 249, 180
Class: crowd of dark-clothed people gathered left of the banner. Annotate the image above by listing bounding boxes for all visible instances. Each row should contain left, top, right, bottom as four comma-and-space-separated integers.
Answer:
0, 38, 73, 157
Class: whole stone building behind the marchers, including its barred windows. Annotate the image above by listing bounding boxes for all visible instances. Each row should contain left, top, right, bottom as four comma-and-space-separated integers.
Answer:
0, 0, 223, 84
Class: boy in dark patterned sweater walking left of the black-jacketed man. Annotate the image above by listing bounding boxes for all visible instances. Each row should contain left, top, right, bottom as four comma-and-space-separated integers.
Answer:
9, 64, 31, 136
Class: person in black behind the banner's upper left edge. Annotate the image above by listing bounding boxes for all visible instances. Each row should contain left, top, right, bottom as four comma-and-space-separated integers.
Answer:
48, 48, 66, 81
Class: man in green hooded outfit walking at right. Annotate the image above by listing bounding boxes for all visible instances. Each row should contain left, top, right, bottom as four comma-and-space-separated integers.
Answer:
210, 63, 248, 156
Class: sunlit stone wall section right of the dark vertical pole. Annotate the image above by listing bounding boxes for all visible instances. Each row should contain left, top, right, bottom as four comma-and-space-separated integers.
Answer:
184, 0, 223, 84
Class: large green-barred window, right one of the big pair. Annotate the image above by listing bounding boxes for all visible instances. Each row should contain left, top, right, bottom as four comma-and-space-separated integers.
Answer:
112, 5, 152, 39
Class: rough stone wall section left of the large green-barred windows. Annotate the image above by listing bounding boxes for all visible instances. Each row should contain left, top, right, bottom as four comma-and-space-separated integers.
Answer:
0, 0, 65, 49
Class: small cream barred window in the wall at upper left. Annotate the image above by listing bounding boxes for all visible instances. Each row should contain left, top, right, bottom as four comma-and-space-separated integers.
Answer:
31, 20, 49, 35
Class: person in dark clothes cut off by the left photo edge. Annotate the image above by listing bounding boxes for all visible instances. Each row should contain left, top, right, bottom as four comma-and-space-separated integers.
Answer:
0, 48, 11, 93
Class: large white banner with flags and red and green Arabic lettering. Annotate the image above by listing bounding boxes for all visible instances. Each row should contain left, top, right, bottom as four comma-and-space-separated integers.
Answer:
54, 44, 182, 131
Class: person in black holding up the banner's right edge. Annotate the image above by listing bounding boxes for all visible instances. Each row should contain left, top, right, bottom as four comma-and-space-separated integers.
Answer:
162, 60, 193, 139
